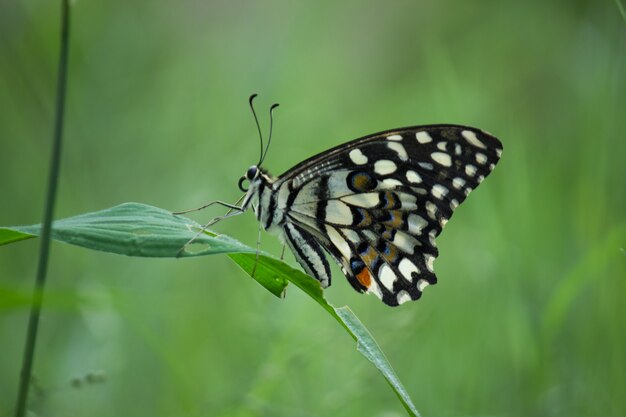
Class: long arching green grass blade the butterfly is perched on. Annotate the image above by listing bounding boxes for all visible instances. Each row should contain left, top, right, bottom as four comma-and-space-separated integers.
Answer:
0, 203, 419, 417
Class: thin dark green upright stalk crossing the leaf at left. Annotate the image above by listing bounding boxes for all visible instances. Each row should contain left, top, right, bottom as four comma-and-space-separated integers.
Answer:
15, 0, 70, 417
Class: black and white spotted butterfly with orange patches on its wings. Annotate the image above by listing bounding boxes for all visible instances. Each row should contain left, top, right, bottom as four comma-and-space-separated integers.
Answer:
183, 95, 502, 306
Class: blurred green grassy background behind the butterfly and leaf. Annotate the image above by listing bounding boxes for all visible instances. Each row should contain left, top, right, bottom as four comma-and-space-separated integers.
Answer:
0, 0, 626, 417
